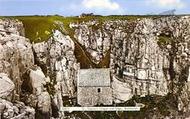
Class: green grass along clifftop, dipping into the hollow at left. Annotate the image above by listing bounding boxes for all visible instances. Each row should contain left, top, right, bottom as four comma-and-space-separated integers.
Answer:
13, 16, 152, 42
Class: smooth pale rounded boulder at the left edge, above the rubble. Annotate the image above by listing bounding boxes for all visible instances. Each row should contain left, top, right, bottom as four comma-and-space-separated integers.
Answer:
0, 73, 15, 98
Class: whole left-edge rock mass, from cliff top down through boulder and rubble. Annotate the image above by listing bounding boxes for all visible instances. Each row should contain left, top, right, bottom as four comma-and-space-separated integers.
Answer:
0, 19, 35, 119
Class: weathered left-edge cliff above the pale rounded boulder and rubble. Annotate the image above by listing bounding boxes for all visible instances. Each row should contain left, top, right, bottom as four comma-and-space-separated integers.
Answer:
0, 19, 34, 99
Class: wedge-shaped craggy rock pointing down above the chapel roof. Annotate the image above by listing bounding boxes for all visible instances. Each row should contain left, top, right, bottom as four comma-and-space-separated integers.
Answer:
70, 21, 111, 64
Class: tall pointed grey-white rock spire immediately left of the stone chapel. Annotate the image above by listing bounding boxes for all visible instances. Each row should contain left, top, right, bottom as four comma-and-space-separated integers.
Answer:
33, 30, 79, 116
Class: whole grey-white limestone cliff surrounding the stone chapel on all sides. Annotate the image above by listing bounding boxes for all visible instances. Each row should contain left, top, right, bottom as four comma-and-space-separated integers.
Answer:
0, 16, 190, 119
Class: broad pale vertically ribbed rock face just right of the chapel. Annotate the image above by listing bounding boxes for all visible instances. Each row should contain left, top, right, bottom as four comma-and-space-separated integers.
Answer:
110, 19, 168, 102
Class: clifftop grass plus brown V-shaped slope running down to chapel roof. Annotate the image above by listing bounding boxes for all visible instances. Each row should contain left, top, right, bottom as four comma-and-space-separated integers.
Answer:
0, 15, 163, 68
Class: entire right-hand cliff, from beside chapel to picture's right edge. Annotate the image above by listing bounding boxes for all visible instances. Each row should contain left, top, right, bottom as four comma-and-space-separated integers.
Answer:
111, 17, 190, 118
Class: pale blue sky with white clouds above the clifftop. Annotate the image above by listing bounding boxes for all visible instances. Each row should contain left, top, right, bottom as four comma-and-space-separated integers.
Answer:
0, 0, 190, 16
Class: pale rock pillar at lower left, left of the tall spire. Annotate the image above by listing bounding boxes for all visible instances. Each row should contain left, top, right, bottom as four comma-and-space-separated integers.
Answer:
29, 66, 51, 118
